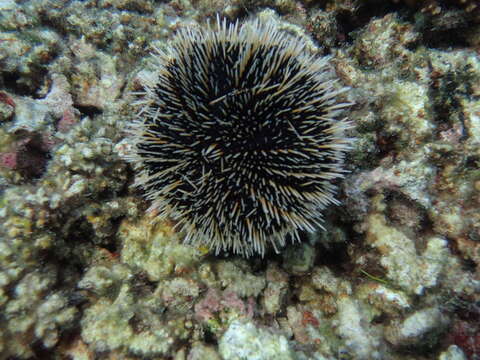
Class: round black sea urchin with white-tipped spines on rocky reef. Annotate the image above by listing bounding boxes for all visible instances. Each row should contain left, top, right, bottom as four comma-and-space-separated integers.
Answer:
128, 21, 351, 257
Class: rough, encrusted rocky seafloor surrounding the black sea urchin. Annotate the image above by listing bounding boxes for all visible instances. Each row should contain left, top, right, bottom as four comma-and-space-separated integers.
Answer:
0, 0, 480, 360
